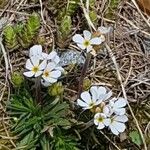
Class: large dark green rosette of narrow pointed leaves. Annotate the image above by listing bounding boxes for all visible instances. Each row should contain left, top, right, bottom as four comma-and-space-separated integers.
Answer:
7, 90, 71, 150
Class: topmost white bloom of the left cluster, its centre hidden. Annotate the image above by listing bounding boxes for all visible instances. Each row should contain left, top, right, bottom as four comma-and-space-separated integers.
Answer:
29, 45, 42, 59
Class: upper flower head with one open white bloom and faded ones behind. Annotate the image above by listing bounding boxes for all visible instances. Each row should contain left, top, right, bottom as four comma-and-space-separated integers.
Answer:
72, 26, 110, 55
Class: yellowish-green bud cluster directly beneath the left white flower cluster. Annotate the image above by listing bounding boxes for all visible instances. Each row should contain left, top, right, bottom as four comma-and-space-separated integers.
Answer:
48, 82, 64, 96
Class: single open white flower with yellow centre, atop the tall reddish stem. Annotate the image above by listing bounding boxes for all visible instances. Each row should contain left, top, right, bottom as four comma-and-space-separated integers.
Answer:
72, 30, 102, 53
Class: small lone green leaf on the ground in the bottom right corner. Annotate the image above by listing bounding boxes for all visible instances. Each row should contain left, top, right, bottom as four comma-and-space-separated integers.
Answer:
129, 130, 142, 146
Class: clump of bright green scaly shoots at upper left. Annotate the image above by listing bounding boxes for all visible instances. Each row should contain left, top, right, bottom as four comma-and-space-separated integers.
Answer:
3, 13, 40, 50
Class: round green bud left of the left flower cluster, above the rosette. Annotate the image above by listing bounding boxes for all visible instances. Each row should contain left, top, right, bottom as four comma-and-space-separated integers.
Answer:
11, 72, 24, 87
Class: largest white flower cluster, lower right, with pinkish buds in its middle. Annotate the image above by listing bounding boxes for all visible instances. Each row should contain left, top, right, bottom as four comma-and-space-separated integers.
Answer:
77, 86, 128, 135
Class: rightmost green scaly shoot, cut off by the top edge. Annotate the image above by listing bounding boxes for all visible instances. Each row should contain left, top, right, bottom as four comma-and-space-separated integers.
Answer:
106, 0, 121, 19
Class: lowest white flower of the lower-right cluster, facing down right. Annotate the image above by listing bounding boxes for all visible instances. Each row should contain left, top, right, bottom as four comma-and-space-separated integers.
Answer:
109, 115, 128, 135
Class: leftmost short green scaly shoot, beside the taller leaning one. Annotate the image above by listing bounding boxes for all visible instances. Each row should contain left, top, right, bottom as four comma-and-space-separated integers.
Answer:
3, 26, 19, 50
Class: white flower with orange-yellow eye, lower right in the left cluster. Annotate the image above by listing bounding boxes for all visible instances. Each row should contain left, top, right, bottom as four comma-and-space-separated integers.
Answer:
42, 62, 61, 83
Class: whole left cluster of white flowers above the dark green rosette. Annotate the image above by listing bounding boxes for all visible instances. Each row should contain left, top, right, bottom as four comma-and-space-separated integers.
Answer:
23, 45, 64, 86
